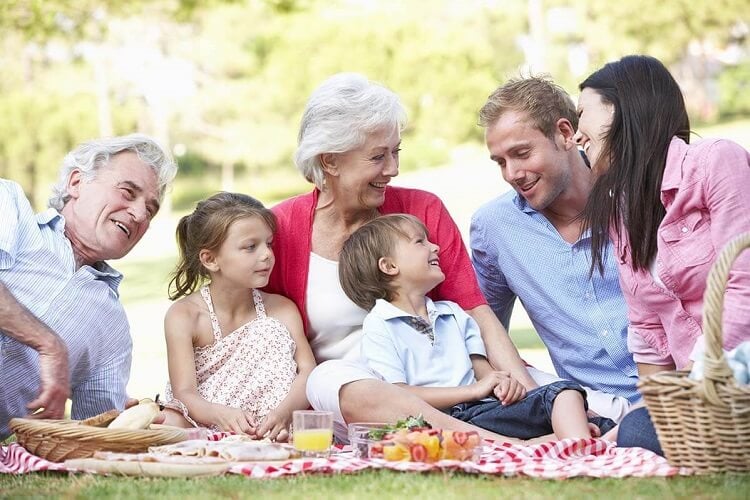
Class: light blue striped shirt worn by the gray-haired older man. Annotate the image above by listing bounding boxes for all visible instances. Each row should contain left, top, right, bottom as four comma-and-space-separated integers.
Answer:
0, 179, 132, 439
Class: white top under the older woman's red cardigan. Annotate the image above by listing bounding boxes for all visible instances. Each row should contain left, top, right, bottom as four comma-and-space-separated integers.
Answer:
306, 252, 367, 363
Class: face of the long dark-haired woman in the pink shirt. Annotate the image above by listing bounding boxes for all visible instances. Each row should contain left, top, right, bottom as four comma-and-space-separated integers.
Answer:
573, 87, 615, 176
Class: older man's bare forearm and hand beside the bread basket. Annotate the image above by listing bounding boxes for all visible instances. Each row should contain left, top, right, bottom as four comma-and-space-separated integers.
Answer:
0, 282, 70, 418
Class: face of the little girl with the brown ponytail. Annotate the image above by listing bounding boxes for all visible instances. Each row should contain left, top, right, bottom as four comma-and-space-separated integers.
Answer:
204, 217, 275, 288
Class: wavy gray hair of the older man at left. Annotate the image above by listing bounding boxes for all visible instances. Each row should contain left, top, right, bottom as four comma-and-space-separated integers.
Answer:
47, 134, 177, 211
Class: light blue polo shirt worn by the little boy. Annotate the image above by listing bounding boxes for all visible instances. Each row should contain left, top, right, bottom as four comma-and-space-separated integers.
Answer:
361, 297, 487, 387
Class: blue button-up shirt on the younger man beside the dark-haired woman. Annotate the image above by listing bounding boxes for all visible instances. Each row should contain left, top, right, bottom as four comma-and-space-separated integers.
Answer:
471, 191, 640, 402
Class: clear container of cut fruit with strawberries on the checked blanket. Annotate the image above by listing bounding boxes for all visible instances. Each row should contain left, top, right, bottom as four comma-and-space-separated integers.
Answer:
368, 416, 482, 463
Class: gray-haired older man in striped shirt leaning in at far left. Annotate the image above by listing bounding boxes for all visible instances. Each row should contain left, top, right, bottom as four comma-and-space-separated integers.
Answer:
0, 134, 177, 439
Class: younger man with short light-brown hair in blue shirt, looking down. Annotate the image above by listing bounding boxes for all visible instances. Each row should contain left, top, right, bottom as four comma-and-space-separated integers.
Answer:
471, 77, 639, 421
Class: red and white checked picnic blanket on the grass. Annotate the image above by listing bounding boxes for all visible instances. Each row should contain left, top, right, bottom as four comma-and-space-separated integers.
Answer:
0, 438, 691, 479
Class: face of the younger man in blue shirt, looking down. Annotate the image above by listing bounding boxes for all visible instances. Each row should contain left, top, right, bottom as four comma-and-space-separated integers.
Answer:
485, 111, 573, 211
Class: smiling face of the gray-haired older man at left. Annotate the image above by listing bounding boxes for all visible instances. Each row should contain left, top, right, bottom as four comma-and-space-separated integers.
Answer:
62, 151, 159, 264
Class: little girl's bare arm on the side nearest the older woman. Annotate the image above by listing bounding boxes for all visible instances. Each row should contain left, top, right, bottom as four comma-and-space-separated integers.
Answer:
257, 295, 315, 441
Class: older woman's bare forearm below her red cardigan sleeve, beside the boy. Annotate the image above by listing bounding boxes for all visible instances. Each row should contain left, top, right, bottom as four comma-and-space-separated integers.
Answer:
466, 304, 538, 390
